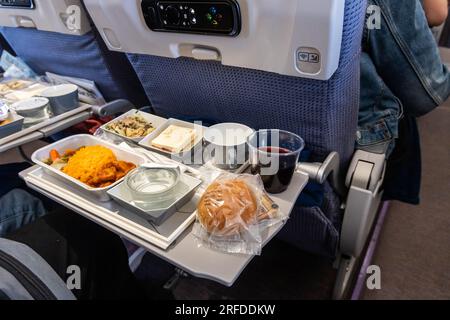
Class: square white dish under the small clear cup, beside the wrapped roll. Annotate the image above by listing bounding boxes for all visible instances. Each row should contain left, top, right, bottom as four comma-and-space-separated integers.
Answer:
108, 170, 202, 225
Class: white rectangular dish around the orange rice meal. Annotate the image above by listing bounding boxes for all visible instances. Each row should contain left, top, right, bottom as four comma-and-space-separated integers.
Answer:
31, 134, 146, 202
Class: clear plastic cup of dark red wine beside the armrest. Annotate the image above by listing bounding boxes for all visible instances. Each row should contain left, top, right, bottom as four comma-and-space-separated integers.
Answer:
247, 129, 305, 194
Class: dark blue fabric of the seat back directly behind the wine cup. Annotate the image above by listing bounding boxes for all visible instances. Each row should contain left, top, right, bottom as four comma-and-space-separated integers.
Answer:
128, 0, 366, 257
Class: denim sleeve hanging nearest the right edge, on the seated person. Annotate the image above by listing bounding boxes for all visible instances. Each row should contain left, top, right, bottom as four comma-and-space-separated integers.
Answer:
363, 0, 450, 117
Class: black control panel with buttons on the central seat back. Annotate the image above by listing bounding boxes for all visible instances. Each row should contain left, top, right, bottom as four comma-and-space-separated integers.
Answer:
141, 0, 241, 36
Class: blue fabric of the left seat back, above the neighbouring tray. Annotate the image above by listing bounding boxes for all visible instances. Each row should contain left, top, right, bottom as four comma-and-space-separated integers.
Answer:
0, 27, 148, 107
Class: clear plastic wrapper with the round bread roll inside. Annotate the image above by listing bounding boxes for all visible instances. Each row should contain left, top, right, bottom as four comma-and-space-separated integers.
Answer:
193, 173, 287, 255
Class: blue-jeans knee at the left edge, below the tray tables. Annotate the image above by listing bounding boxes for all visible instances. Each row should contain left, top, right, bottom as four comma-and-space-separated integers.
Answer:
0, 189, 47, 237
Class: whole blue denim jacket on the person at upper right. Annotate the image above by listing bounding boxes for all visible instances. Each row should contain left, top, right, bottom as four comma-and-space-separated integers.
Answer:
357, 0, 450, 156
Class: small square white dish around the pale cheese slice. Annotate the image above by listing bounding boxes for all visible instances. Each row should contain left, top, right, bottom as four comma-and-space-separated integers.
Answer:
139, 118, 205, 162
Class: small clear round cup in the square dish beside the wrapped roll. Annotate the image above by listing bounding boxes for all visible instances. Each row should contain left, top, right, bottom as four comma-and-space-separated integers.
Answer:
125, 164, 181, 202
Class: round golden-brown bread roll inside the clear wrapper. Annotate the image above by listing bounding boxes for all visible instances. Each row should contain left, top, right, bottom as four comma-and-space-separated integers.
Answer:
198, 179, 258, 235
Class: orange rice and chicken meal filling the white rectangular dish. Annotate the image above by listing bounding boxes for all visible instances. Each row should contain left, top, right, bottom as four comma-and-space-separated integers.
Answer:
46, 146, 136, 188
